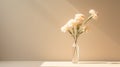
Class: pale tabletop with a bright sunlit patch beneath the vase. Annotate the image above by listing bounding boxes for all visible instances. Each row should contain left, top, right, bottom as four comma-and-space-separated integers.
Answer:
0, 61, 120, 67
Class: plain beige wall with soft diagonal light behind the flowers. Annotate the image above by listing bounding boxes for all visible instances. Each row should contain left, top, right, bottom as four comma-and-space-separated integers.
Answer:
0, 0, 120, 60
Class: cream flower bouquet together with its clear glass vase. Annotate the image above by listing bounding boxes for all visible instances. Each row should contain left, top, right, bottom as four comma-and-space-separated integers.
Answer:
61, 9, 97, 63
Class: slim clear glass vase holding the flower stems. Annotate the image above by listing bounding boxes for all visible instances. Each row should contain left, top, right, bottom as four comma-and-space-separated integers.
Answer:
72, 42, 79, 63
